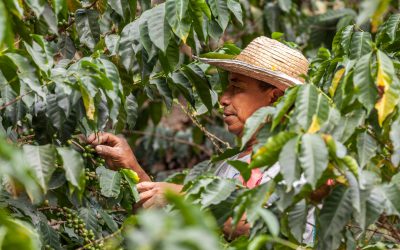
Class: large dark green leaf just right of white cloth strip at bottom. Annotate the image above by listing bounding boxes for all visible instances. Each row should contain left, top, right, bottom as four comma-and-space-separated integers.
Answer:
319, 186, 352, 248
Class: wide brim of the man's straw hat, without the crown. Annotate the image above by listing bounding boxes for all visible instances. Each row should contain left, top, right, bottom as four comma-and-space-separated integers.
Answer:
193, 56, 302, 90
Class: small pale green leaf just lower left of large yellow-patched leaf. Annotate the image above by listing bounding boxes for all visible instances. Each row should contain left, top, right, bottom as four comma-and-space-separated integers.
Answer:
357, 131, 378, 168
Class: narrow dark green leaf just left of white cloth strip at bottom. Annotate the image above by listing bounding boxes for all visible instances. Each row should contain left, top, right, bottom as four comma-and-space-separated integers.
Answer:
288, 199, 307, 242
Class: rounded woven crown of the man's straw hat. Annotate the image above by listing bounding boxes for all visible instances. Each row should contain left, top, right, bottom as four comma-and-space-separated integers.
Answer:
235, 36, 308, 82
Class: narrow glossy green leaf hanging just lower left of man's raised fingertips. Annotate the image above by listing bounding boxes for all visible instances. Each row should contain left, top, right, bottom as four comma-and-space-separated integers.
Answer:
57, 148, 85, 191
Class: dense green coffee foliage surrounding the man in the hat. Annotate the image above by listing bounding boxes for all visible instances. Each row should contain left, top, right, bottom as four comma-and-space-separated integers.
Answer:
0, 0, 400, 250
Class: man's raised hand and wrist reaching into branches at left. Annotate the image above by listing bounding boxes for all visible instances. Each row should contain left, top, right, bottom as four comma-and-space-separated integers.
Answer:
87, 132, 150, 181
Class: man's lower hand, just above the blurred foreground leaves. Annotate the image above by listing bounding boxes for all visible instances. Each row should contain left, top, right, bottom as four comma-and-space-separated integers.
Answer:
136, 182, 183, 208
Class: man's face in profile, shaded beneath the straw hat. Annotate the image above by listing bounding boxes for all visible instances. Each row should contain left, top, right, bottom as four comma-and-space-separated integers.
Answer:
220, 73, 283, 136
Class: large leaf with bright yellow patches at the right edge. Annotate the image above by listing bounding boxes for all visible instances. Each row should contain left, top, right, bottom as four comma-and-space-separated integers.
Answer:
375, 50, 400, 126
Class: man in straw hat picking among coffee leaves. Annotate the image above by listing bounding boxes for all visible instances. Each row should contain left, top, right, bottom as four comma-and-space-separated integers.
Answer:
88, 37, 308, 227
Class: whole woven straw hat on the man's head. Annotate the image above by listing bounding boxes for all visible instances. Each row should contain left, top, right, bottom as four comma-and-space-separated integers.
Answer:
194, 36, 308, 90
